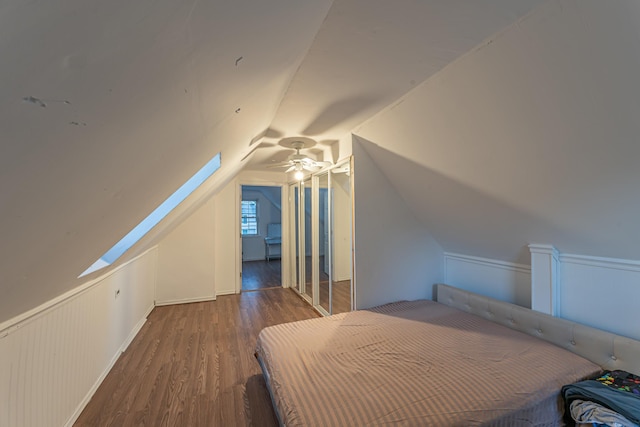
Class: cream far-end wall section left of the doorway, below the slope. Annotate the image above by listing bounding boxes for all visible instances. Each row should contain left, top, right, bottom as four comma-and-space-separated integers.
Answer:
156, 199, 215, 305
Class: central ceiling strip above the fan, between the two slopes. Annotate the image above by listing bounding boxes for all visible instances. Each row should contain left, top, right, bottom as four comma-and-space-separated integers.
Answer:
247, 0, 541, 169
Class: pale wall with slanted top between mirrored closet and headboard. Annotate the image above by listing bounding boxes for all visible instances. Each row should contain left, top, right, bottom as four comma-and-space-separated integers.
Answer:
352, 137, 443, 309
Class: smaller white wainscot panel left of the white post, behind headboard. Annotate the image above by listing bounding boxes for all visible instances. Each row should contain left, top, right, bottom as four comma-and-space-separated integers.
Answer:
444, 253, 531, 308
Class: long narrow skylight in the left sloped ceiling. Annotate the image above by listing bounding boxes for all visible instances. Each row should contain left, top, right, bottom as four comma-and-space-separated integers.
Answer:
78, 153, 220, 277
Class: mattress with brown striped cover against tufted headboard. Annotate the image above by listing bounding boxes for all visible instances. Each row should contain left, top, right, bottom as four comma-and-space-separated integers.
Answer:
256, 301, 601, 426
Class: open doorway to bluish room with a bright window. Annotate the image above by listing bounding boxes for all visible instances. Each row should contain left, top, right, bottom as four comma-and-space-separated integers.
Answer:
240, 185, 282, 292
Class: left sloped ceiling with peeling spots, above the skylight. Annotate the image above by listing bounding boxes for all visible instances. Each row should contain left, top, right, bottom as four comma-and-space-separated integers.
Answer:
0, 0, 331, 321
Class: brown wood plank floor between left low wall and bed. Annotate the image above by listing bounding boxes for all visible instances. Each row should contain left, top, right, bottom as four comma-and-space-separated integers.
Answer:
74, 288, 318, 426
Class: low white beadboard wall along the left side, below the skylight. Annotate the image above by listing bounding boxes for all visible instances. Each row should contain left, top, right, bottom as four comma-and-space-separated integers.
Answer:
0, 248, 157, 427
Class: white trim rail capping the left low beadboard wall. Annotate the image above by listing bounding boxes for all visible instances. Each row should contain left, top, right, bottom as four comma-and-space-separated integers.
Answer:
0, 245, 158, 339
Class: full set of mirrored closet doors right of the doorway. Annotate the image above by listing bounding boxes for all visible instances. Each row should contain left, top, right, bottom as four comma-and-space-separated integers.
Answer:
289, 161, 353, 314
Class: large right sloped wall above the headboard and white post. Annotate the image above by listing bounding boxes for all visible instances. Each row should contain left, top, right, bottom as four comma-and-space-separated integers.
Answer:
354, 0, 640, 264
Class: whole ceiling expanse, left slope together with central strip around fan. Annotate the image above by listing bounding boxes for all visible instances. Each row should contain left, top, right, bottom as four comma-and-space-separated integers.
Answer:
0, 0, 541, 322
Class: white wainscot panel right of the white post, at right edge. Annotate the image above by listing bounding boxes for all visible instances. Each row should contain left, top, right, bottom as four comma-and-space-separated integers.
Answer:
559, 254, 640, 340
